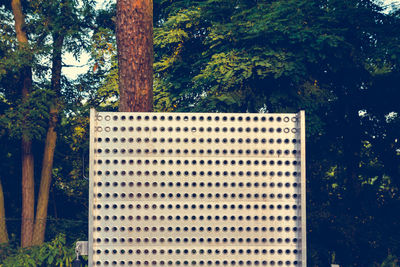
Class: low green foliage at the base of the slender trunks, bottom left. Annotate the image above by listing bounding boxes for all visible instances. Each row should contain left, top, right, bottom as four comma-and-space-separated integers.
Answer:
0, 234, 75, 267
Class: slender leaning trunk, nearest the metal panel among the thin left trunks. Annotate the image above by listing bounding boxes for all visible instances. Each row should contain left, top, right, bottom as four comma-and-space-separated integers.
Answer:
33, 34, 64, 245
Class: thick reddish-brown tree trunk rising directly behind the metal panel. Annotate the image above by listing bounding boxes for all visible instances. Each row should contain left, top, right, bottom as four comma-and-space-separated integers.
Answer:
116, 0, 153, 111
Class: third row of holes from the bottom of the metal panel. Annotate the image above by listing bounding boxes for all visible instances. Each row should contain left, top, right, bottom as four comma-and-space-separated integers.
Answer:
93, 237, 299, 244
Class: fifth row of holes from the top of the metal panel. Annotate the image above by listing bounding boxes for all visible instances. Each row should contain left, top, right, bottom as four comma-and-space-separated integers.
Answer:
95, 159, 298, 166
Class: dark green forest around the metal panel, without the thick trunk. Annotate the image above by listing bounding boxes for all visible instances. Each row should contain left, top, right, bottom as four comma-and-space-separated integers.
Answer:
0, 0, 400, 266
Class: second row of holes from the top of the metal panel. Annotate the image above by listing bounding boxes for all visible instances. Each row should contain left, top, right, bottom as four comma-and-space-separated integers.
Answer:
95, 126, 298, 133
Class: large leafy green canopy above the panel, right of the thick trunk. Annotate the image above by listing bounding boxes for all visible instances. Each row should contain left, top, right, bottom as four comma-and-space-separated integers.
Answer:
154, 1, 400, 111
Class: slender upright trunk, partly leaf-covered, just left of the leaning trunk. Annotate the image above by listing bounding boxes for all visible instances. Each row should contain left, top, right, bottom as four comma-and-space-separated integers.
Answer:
11, 0, 35, 247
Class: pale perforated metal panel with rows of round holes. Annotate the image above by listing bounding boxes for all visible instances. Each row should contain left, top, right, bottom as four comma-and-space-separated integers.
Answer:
89, 110, 306, 266
